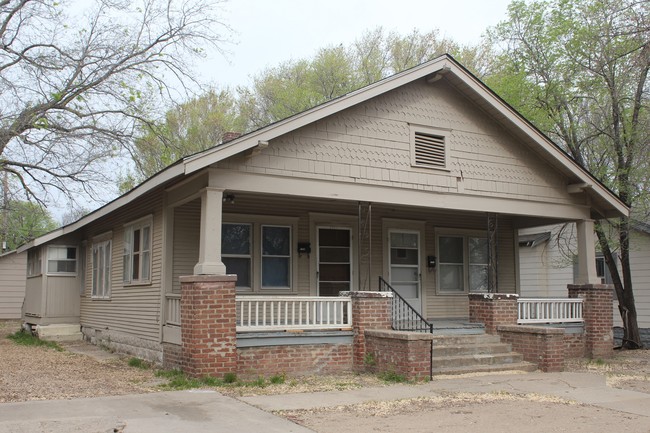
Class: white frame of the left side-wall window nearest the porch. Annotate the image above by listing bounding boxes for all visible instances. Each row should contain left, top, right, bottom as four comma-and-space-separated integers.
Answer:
122, 215, 153, 286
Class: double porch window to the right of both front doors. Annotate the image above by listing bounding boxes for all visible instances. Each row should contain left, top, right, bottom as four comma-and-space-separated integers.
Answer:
438, 235, 488, 293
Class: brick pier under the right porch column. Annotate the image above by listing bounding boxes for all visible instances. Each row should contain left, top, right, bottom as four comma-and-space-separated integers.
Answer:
567, 284, 614, 358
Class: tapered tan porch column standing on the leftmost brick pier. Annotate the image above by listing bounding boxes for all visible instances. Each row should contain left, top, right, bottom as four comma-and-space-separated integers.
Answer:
194, 187, 226, 275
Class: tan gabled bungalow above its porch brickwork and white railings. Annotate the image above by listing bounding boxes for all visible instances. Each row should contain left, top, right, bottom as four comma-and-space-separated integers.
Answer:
16, 55, 629, 359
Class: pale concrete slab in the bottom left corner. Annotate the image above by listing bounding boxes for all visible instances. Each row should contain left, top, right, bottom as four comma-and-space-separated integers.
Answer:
0, 391, 312, 433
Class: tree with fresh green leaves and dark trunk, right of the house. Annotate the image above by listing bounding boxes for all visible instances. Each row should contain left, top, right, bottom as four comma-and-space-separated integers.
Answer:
486, 0, 650, 348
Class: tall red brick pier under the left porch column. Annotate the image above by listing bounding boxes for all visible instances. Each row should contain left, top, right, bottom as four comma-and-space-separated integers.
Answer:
180, 275, 237, 377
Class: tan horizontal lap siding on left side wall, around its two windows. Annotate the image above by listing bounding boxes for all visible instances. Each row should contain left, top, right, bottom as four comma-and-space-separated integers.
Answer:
81, 191, 163, 341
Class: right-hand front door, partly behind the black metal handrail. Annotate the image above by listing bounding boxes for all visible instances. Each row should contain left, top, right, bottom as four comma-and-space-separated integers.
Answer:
388, 230, 422, 313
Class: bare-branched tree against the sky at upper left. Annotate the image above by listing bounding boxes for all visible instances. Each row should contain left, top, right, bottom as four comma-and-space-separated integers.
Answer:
0, 0, 228, 203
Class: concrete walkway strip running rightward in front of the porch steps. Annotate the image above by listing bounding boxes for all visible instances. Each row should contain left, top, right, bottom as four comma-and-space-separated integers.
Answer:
240, 373, 650, 417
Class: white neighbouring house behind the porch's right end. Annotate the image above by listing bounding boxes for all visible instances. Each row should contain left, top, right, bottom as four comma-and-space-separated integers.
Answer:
519, 222, 650, 346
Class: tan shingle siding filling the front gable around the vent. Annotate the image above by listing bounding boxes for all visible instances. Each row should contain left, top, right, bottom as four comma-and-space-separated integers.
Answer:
218, 81, 577, 209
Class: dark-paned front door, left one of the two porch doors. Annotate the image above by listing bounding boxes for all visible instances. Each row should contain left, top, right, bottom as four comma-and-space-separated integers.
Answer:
316, 227, 352, 296
